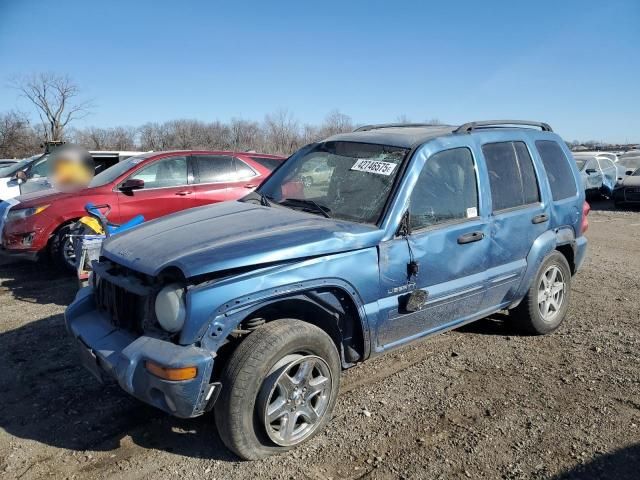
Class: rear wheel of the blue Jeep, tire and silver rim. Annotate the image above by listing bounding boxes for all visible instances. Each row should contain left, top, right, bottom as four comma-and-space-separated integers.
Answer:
512, 250, 571, 335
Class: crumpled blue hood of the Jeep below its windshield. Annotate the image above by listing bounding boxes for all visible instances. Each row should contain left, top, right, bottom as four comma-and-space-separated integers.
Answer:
103, 202, 383, 277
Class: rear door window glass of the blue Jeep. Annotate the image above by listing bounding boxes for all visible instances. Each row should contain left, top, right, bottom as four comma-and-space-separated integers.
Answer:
482, 142, 540, 212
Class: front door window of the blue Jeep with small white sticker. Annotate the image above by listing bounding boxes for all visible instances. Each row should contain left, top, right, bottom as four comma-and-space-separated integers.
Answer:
409, 148, 478, 229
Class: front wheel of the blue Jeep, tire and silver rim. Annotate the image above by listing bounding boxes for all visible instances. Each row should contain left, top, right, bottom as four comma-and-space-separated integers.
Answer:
214, 319, 341, 460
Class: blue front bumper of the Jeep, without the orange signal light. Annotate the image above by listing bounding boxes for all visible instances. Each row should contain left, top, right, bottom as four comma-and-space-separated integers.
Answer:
65, 287, 221, 418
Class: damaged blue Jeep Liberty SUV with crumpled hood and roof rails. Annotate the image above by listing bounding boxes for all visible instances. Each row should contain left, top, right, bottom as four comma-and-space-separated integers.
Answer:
65, 120, 589, 459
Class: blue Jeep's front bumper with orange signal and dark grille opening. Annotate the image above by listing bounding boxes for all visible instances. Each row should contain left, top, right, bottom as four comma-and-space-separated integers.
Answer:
65, 261, 220, 418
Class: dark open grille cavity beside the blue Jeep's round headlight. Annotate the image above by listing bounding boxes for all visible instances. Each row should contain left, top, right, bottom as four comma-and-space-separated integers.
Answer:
95, 277, 148, 334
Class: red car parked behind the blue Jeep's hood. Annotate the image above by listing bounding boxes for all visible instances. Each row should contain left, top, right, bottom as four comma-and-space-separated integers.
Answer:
0, 151, 284, 267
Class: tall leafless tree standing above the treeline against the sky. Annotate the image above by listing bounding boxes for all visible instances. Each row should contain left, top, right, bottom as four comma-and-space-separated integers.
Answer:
11, 73, 91, 140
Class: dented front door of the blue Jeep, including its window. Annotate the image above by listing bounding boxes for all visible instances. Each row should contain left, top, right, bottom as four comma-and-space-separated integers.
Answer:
377, 147, 490, 349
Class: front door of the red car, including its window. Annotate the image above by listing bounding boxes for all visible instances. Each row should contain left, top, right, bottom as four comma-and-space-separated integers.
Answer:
114, 156, 195, 223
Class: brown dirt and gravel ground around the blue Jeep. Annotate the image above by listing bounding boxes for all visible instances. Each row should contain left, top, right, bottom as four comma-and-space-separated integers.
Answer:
0, 200, 640, 479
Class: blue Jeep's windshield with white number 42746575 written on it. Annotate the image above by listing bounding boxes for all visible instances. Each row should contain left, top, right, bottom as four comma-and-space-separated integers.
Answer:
259, 142, 409, 223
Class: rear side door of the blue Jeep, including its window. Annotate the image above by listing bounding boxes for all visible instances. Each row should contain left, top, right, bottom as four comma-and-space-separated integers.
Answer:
482, 140, 549, 309
